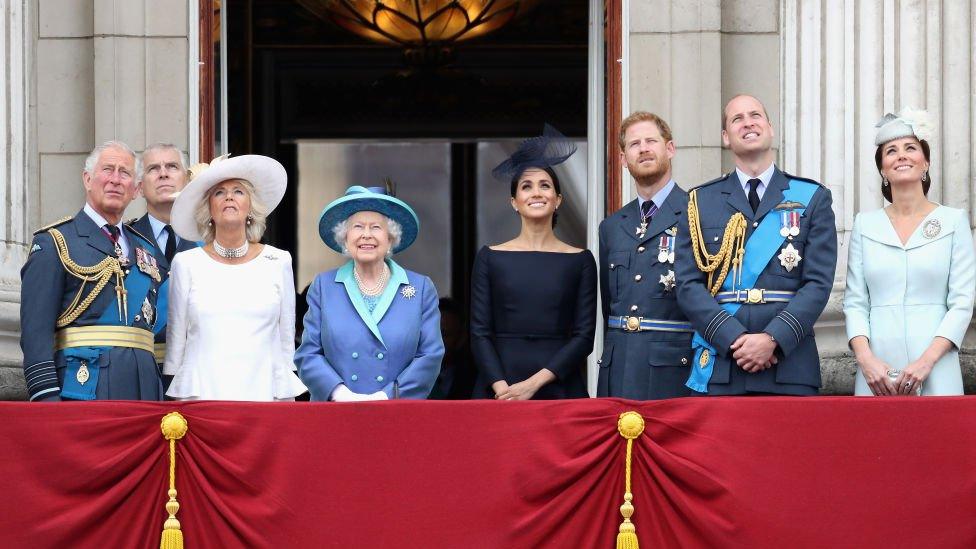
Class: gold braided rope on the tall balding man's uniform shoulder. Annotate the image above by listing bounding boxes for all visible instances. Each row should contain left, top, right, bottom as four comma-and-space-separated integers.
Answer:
688, 189, 748, 295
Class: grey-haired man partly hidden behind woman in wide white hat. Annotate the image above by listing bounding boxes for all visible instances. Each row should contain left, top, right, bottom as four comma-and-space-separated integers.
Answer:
130, 143, 197, 372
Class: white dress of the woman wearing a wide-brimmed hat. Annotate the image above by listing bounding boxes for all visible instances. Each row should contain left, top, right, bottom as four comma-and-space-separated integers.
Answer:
163, 246, 306, 401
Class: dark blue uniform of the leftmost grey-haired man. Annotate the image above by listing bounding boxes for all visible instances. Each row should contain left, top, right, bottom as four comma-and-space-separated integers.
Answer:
20, 210, 162, 400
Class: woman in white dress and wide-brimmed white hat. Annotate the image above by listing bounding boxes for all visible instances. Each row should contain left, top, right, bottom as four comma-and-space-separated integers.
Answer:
163, 155, 306, 401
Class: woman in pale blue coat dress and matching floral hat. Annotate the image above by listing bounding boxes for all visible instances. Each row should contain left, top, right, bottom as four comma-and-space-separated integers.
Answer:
844, 109, 976, 395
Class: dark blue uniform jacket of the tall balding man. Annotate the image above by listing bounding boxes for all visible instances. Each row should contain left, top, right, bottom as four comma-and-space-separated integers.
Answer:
676, 168, 837, 395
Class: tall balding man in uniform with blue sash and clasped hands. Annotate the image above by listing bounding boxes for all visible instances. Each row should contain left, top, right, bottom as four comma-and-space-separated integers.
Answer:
675, 95, 837, 395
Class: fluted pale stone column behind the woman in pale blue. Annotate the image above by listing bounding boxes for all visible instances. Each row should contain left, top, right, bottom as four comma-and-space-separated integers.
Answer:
782, 0, 976, 393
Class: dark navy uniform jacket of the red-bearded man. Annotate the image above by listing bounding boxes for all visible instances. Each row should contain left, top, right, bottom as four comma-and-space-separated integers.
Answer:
597, 185, 692, 400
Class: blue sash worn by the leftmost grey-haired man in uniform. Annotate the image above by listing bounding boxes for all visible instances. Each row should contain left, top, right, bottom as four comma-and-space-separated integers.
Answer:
61, 246, 152, 400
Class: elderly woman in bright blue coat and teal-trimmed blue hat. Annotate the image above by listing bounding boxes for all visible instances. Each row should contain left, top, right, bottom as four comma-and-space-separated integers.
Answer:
295, 186, 444, 402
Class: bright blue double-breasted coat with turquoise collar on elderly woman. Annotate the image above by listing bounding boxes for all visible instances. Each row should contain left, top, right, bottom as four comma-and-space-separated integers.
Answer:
295, 261, 444, 400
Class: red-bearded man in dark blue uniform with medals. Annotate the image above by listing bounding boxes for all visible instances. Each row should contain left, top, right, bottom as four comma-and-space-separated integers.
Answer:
597, 111, 693, 400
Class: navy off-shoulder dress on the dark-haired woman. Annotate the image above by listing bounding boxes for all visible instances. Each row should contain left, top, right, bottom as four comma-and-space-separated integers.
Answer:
471, 247, 597, 399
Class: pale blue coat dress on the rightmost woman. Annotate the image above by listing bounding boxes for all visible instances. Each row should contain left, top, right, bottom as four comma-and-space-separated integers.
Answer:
844, 206, 976, 395
